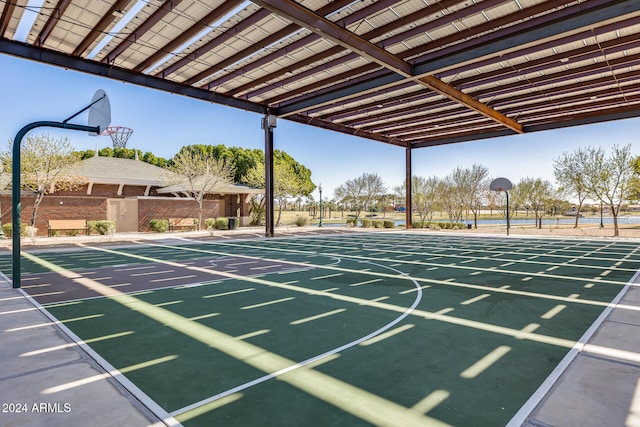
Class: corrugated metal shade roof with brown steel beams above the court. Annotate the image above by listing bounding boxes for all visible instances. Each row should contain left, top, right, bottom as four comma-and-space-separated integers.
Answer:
0, 0, 640, 147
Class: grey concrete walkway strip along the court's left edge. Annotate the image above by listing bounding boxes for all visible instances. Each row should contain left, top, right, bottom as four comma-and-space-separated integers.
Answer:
0, 280, 170, 427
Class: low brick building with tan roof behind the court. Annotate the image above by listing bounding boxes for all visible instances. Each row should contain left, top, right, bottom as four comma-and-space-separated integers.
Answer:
0, 157, 263, 236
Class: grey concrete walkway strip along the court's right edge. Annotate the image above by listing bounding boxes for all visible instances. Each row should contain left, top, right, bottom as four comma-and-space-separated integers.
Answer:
524, 274, 640, 427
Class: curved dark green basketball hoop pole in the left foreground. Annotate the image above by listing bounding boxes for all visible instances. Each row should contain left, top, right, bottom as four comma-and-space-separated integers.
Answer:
11, 121, 100, 288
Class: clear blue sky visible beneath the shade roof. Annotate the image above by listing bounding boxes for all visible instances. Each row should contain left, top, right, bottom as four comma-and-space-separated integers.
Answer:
0, 55, 640, 199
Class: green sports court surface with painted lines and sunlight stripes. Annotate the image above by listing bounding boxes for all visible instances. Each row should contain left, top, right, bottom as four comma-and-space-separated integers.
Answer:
5, 233, 640, 426
